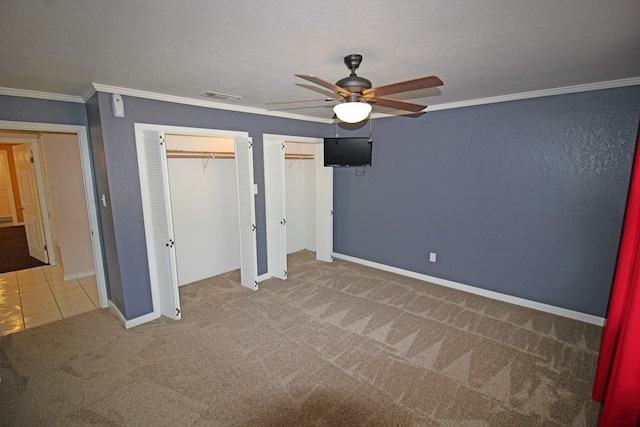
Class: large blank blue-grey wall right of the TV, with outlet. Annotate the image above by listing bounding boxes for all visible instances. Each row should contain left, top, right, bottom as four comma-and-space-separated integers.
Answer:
334, 86, 640, 317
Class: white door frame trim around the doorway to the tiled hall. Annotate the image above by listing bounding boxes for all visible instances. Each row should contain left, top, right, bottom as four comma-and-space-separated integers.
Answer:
0, 120, 109, 308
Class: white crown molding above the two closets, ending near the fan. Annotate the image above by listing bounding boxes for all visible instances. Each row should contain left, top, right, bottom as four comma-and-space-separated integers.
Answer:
93, 83, 333, 123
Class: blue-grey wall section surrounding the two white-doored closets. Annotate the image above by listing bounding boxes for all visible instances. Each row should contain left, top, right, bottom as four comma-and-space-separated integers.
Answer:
88, 93, 331, 319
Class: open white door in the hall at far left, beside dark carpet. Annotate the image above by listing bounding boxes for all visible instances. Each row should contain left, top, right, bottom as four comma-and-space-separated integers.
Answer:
12, 144, 49, 263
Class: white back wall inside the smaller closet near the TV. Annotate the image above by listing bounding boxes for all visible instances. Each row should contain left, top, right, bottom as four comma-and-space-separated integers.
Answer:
285, 141, 316, 254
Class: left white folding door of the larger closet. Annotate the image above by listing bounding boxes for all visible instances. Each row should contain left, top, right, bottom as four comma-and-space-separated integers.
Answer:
142, 131, 182, 320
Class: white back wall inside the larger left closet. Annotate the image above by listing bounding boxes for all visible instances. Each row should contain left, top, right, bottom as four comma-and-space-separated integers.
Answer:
166, 135, 240, 286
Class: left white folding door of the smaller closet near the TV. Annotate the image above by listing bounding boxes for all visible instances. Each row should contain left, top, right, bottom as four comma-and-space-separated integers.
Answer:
264, 140, 287, 279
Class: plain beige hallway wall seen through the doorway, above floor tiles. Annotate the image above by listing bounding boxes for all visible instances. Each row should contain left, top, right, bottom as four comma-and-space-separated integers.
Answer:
42, 133, 95, 277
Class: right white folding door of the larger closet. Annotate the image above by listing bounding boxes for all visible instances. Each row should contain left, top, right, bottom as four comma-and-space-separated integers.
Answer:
235, 137, 258, 290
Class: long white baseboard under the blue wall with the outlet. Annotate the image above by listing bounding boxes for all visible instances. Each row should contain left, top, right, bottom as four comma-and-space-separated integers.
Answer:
332, 252, 605, 326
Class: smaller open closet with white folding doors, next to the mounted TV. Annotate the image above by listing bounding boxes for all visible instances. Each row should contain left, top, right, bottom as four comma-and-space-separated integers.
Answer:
264, 134, 333, 279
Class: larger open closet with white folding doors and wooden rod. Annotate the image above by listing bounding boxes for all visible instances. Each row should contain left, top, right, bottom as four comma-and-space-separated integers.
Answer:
134, 123, 258, 324
